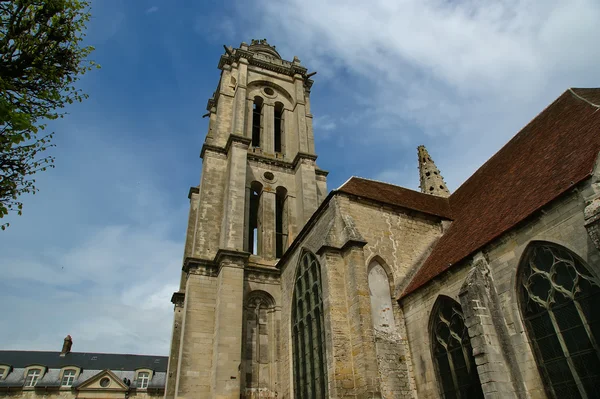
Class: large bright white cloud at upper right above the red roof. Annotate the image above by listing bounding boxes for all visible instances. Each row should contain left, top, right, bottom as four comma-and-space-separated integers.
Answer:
241, 0, 600, 186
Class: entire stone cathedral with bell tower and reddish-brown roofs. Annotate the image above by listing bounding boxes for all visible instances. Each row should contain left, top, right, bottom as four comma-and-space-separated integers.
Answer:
165, 40, 600, 399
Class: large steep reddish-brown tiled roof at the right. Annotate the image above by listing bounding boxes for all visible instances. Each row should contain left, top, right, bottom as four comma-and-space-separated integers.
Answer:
402, 88, 600, 296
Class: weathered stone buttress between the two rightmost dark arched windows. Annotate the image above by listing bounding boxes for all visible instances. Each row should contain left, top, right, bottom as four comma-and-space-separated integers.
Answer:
459, 253, 527, 398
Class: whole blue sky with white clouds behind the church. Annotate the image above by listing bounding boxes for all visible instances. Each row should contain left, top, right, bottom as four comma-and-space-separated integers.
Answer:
0, 0, 600, 355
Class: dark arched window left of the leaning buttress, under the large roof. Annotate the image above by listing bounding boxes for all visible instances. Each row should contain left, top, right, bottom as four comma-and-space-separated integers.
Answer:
430, 296, 483, 399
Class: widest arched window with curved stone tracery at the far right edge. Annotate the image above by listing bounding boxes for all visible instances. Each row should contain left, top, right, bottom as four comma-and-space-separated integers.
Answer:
519, 242, 600, 398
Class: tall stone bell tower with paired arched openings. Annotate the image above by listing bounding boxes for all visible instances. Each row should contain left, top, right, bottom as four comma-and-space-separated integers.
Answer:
166, 40, 327, 399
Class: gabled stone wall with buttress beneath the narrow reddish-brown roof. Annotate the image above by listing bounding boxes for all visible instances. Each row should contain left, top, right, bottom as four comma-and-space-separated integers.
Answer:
279, 194, 441, 398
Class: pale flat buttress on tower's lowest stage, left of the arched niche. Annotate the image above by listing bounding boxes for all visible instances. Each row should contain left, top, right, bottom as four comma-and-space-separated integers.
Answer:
211, 249, 248, 399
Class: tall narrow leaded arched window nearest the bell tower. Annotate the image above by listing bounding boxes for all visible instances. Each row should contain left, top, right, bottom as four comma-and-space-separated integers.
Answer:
292, 251, 327, 399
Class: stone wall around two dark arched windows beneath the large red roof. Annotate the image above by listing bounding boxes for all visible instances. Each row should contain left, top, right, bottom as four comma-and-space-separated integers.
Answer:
400, 182, 600, 398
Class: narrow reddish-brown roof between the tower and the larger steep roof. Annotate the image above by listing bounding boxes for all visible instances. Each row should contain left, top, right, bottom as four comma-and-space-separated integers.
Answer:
336, 176, 451, 219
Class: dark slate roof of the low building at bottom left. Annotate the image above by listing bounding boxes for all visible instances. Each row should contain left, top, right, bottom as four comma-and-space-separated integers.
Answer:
0, 350, 169, 372
